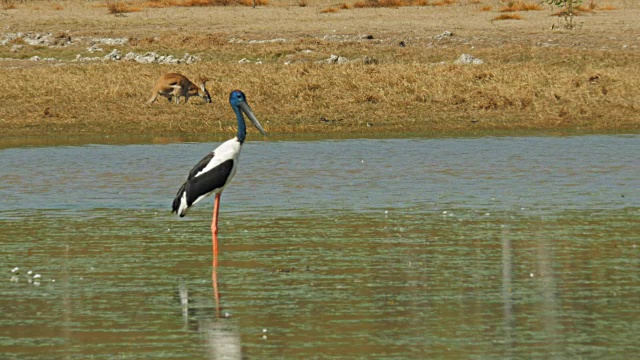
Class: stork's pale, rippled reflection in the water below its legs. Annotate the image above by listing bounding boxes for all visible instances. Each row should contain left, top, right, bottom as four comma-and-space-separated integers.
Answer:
178, 267, 242, 360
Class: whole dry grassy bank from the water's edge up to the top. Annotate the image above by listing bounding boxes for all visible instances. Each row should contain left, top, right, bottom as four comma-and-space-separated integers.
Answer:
0, 1, 640, 137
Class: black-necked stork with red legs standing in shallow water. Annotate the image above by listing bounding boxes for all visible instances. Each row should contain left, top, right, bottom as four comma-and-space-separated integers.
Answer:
173, 90, 267, 266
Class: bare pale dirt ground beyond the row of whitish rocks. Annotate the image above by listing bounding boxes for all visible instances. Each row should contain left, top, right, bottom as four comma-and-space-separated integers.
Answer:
0, 0, 640, 51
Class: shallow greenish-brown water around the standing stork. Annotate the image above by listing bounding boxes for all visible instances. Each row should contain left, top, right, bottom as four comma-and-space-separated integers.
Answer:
0, 135, 640, 359
